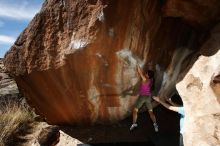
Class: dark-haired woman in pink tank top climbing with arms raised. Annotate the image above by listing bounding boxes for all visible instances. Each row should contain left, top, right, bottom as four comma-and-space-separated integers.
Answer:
130, 65, 158, 132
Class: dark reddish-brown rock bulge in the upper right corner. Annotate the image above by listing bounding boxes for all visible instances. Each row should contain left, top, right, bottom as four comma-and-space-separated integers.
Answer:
163, 0, 220, 27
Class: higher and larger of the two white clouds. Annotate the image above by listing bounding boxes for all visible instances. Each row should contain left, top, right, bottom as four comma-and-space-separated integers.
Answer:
0, 2, 40, 20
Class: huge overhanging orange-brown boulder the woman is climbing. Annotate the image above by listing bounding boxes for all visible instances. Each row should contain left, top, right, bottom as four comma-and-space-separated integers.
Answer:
4, 0, 219, 135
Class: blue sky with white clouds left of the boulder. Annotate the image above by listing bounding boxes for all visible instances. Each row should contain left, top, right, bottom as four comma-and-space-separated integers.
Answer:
0, 0, 44, 58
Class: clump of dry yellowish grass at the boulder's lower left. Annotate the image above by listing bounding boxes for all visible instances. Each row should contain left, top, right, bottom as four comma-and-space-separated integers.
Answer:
0, 100, 34, 146
